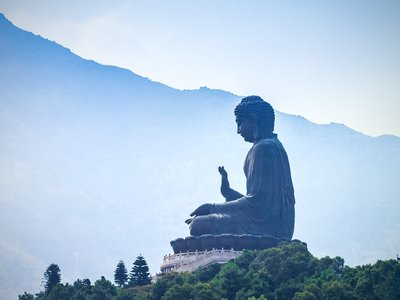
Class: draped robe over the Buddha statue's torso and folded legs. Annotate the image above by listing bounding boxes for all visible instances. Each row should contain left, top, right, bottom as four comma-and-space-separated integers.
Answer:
192, 134, 295, 239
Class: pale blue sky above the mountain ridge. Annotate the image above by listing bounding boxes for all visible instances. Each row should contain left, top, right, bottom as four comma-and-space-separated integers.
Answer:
0, 0, 400, 136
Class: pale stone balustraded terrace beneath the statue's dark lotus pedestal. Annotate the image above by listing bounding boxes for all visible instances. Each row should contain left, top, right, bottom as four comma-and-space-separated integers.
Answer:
160, 249, 242, 273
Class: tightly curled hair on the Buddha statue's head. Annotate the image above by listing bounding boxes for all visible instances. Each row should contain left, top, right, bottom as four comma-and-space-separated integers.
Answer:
235, 96, 275, 132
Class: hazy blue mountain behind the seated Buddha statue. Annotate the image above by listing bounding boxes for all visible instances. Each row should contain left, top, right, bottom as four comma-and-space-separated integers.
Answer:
0, 15, 400, 299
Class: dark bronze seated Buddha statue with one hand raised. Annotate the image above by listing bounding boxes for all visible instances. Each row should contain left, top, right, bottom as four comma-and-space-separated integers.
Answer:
186, 96, 295, 240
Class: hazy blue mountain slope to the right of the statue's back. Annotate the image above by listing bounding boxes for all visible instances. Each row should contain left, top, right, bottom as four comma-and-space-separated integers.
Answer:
280, 116, 400, 264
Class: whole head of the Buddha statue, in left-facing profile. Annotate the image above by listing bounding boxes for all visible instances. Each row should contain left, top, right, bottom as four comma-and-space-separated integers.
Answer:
235, 96, 275, 142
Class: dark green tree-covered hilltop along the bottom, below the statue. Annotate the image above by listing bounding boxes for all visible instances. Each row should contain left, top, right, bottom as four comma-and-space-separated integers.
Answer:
19, 243, 400, 300
